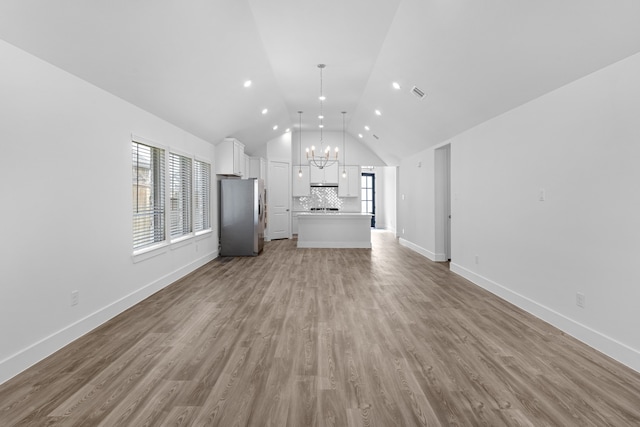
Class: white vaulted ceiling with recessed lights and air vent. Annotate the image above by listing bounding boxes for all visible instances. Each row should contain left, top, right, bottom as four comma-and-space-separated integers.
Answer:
0, 0, 640, 165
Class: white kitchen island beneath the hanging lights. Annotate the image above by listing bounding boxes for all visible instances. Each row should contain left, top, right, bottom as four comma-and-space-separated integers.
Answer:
298, 212, 371, 248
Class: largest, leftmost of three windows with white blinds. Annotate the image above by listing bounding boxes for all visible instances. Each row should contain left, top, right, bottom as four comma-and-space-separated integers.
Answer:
131, 141, 165, 249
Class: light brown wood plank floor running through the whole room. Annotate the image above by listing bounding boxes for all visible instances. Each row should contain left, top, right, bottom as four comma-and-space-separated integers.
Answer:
0, 232, 640, 426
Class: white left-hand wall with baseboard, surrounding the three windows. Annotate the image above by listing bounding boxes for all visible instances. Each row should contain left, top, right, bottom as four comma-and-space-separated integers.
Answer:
0, 41, 217, 382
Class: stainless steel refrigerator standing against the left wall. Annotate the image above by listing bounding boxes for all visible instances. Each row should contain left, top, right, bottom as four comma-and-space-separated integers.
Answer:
220, 178, 266, 256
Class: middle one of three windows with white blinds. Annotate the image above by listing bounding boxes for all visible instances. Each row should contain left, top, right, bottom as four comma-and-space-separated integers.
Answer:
169, 153, 192, 238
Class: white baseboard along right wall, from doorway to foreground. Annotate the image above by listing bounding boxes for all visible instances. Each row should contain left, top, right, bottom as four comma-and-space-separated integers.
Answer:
450, 262, 640, 372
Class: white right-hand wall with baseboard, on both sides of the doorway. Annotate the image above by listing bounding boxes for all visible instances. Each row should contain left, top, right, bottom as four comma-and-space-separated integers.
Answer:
399, 54, 640, 371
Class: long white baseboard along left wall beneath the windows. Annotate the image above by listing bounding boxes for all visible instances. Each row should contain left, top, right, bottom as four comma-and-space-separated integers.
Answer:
0, 251, 218, 384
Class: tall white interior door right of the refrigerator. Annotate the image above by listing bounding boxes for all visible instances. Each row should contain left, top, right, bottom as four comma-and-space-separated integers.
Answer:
267, 161, 291, 240
